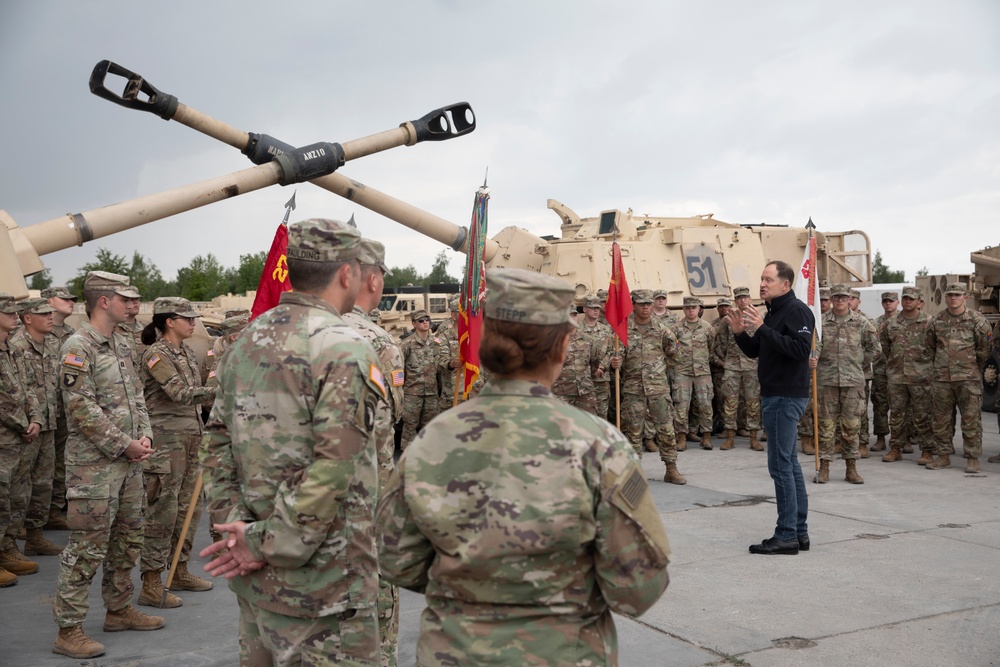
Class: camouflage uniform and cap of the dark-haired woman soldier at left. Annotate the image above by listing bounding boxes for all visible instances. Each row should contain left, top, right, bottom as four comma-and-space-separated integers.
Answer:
140, 298, 215, 573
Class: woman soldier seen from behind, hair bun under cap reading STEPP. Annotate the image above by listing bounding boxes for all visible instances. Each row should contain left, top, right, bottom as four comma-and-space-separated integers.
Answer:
377, 269, 669, 666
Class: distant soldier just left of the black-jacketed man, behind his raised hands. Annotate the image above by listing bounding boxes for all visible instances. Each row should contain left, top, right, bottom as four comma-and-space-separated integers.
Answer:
713, 287, 764, 452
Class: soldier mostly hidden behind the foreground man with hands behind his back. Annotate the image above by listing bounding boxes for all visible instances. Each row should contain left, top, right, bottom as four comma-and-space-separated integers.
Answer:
344, 238, 403, 667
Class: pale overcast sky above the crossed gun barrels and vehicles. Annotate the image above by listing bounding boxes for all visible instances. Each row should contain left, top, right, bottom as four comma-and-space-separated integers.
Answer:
0, 0, 1000, 290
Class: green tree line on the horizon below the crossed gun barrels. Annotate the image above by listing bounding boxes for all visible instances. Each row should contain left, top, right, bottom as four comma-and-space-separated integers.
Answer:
29, 248, 458, 301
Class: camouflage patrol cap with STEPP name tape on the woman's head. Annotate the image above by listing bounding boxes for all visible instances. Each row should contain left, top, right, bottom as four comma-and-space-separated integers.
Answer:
485, 269, 575, 325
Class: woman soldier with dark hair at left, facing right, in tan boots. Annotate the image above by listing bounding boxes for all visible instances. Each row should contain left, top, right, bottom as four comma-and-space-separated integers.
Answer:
139, 297, 215, 607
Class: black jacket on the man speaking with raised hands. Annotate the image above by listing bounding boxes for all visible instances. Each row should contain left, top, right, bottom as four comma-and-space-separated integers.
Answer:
736, 291, 816, 398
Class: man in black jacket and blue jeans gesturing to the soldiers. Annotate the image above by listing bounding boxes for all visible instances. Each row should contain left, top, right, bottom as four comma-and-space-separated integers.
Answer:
727, 261, 815, 555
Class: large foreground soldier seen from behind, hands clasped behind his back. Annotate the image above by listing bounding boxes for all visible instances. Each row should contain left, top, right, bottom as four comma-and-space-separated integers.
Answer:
201, 219, 387, 667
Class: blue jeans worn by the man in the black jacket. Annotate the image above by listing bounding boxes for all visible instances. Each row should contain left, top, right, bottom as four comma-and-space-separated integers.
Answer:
760, 396, 809, 541
